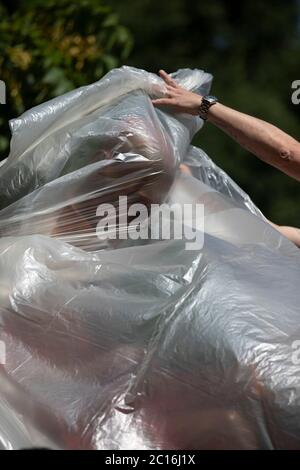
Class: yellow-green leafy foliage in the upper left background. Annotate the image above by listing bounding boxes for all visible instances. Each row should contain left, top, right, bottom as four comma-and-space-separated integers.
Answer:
0, 0, 132, 157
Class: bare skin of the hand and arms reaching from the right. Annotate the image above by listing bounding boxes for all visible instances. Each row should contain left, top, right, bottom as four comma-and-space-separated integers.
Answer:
152, 70, 300, 247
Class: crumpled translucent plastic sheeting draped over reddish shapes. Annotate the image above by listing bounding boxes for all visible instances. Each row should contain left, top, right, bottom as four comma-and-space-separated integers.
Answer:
0, 67, 300, 449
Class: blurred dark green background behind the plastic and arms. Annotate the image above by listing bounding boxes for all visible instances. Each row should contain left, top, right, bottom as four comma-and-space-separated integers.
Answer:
0, 0, 300, 226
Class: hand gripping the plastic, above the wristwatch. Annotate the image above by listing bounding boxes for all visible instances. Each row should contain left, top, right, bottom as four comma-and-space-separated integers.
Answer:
152, 70, 202, 116
